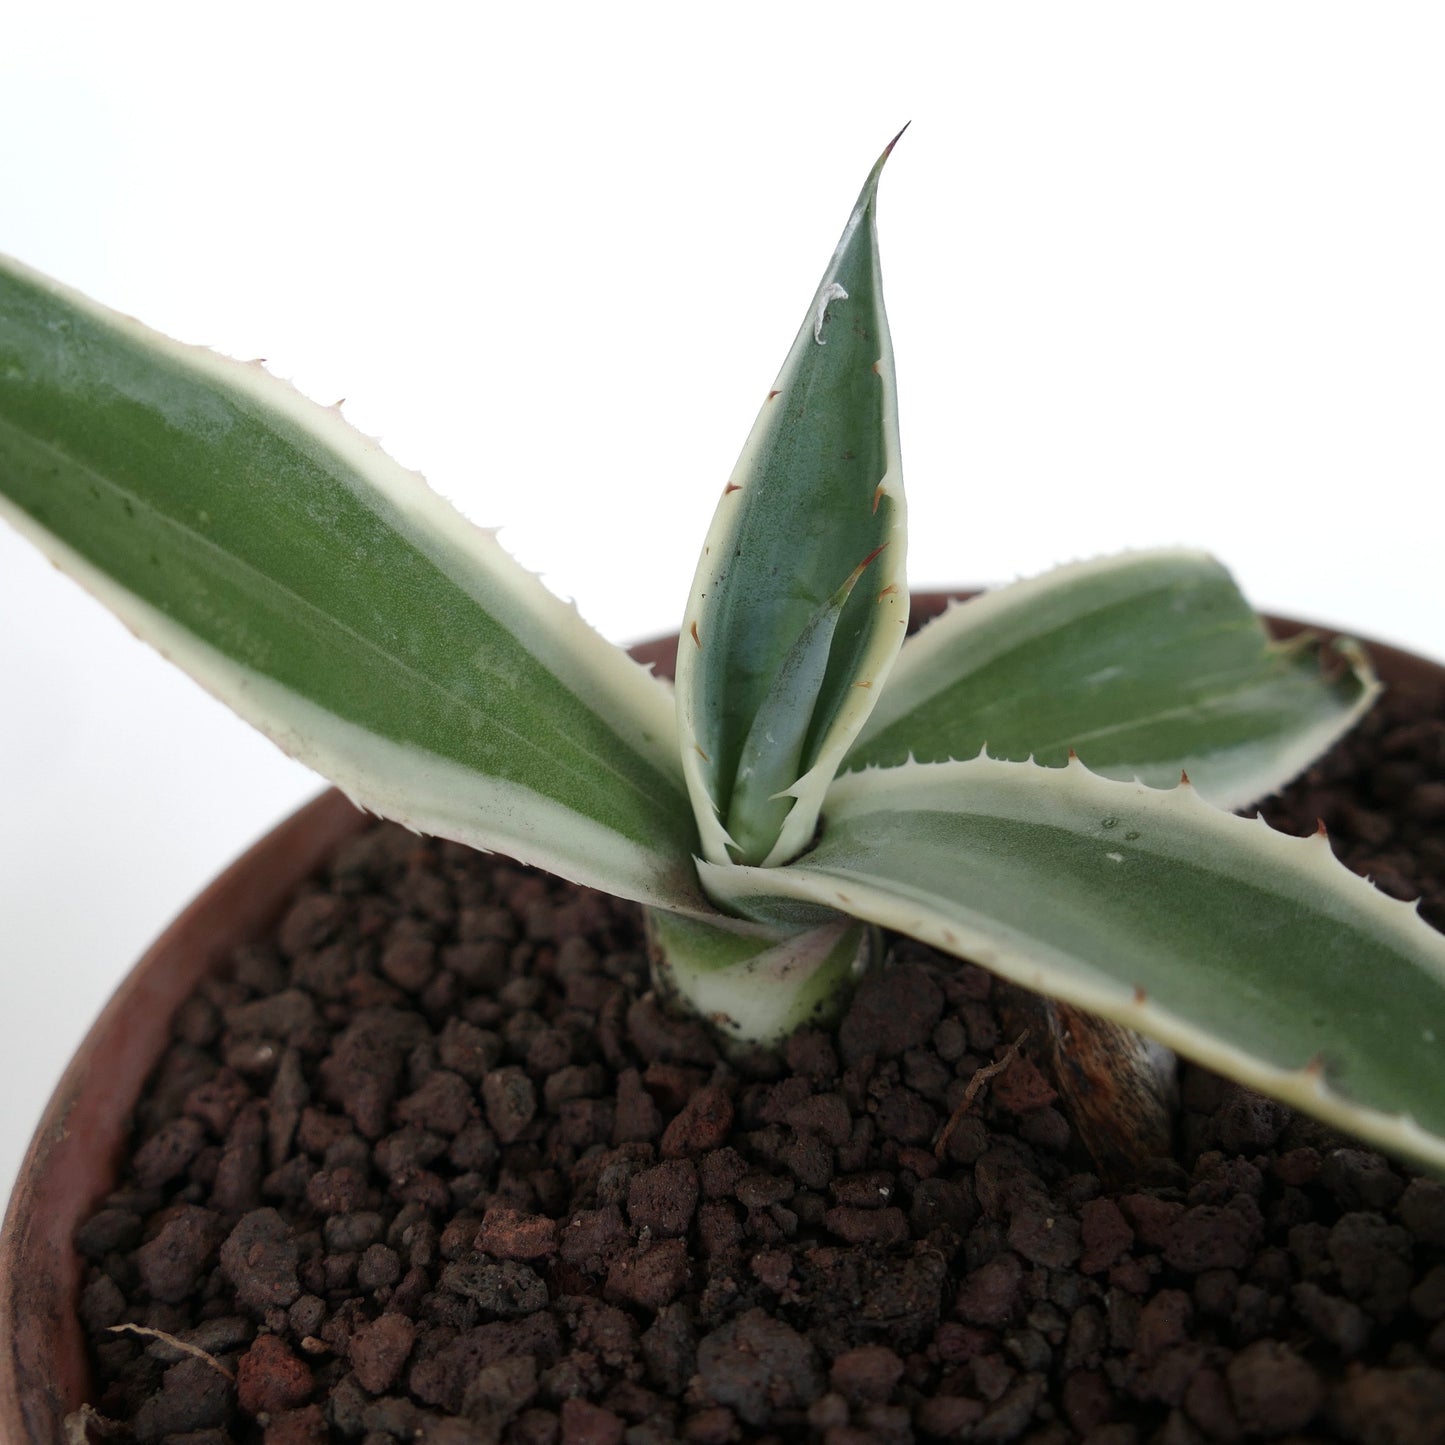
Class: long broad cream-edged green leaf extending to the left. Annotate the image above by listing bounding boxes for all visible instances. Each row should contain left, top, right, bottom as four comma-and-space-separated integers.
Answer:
0, 260, 708, 912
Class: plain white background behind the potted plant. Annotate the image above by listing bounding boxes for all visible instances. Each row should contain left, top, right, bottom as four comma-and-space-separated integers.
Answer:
0, 0, 1445, 1198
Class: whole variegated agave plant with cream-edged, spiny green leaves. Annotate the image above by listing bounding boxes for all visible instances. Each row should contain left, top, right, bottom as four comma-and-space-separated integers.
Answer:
0, 130, 1445, 1166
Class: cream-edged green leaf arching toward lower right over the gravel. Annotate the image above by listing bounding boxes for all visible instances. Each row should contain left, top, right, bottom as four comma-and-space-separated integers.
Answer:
701, 757, 1445, 1169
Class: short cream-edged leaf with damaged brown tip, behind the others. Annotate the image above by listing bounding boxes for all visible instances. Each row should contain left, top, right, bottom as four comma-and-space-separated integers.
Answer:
842, 551, 1380, 808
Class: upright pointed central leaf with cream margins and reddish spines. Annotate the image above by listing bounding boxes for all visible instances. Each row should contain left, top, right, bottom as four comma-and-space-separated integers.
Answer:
676, 137, 907, 866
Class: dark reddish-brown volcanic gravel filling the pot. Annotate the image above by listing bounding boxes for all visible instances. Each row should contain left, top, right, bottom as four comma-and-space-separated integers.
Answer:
77, 664, 1445, 1445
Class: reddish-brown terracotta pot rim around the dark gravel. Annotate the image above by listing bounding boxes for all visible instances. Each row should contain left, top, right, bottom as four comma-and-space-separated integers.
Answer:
0, 594, 1445, 1445
